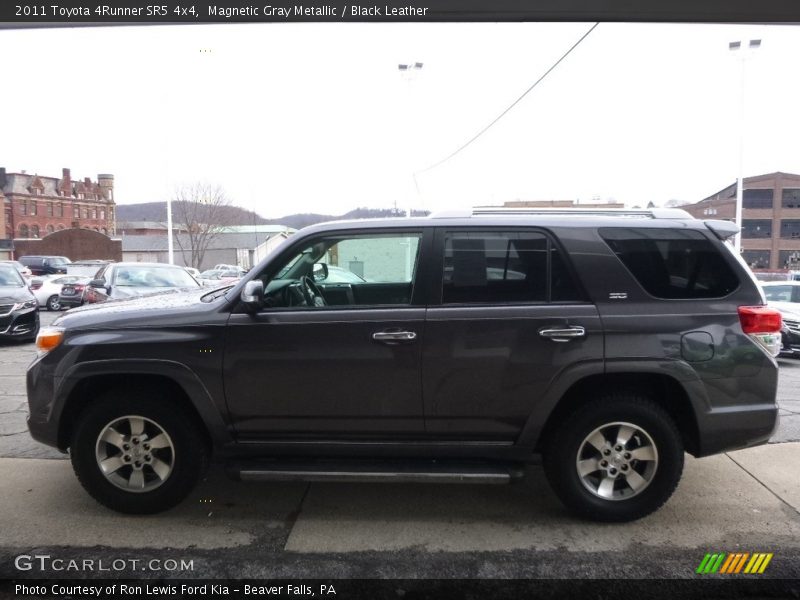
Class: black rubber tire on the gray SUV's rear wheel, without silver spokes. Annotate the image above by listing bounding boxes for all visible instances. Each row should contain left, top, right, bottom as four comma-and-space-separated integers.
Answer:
544, 393, 683, 522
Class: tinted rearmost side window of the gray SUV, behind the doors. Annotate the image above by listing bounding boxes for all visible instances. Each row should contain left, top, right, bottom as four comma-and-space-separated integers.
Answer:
600, 227, 739, 300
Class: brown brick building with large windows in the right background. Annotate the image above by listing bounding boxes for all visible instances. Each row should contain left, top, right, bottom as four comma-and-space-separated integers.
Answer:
681, 172, 800, 269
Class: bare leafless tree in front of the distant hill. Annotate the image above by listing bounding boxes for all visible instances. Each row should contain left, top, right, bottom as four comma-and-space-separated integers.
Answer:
172, 182, 233, 268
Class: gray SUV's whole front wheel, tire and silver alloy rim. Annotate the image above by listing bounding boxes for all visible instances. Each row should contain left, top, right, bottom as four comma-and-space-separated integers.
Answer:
70, 394, 208, 514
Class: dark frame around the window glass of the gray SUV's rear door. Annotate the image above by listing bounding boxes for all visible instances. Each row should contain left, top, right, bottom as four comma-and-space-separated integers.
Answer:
429, 224, 594, 308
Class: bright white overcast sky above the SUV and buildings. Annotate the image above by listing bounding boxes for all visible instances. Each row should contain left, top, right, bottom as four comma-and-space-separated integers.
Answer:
0, 23, 800, 217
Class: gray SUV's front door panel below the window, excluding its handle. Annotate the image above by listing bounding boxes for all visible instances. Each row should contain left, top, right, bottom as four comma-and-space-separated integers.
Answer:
224, 307, 425, 439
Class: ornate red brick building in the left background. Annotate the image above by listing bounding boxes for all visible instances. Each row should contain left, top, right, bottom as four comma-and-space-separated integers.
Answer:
0, 167, 115, 254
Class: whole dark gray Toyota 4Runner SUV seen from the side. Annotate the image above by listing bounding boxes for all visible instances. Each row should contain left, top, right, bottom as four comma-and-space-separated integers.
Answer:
27, 210, 781, 521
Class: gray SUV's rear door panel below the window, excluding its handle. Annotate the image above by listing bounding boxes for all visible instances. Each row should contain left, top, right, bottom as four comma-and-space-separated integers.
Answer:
422, 304, 603, 439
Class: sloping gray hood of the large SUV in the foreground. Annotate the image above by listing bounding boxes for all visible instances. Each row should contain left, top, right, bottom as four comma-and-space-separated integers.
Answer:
53, 289, 220, 329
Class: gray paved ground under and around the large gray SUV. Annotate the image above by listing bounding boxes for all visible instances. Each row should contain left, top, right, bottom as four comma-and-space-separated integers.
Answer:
0, 313, 800, 593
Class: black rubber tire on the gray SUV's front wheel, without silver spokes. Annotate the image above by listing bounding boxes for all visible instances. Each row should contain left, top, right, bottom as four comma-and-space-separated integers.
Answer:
70, 392, 209, 514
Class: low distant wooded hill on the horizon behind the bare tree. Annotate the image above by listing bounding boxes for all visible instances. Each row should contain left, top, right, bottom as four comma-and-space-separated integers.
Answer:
117, 202, 429, 229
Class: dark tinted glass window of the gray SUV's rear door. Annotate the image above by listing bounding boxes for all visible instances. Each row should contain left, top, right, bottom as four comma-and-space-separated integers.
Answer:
442, 232, 580, 304
